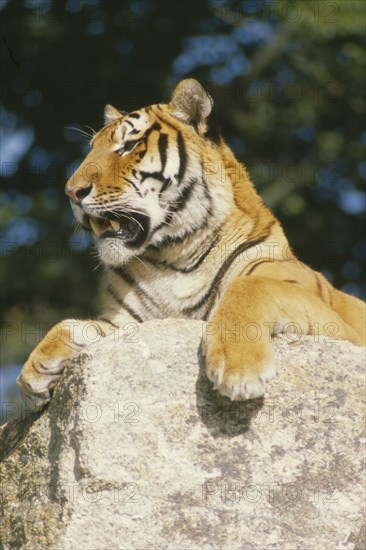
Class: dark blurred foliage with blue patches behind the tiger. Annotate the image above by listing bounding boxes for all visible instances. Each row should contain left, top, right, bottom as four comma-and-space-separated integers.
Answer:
0, 0, 366, 422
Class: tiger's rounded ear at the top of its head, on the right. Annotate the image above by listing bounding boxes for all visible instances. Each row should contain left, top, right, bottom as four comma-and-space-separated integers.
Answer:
169, 78, 213, 134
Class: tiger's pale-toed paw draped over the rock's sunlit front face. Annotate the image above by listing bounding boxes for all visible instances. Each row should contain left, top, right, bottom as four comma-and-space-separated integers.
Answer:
202, 335, 276, 401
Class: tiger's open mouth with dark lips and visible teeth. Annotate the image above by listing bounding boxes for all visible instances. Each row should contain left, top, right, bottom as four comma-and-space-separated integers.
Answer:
86, 212, 150, 247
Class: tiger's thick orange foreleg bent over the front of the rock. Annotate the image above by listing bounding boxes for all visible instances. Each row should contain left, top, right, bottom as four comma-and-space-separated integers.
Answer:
202, 276, 362, 400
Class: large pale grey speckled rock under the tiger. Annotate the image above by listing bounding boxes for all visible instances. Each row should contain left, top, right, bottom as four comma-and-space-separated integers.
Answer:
2, 320, 365, 550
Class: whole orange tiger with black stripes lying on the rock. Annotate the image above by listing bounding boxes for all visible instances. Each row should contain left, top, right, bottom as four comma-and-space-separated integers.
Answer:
17, 79, 366, 410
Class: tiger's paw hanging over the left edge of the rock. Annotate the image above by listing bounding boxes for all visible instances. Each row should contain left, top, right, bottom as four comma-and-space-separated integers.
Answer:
17, 350, 66, 411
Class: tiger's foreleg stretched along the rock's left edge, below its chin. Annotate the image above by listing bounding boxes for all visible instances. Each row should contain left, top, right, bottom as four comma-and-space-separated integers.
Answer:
17, 317, 137, 411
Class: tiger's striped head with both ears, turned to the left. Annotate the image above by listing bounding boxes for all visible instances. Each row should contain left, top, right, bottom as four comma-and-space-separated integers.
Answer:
65, 79, 230, 265
